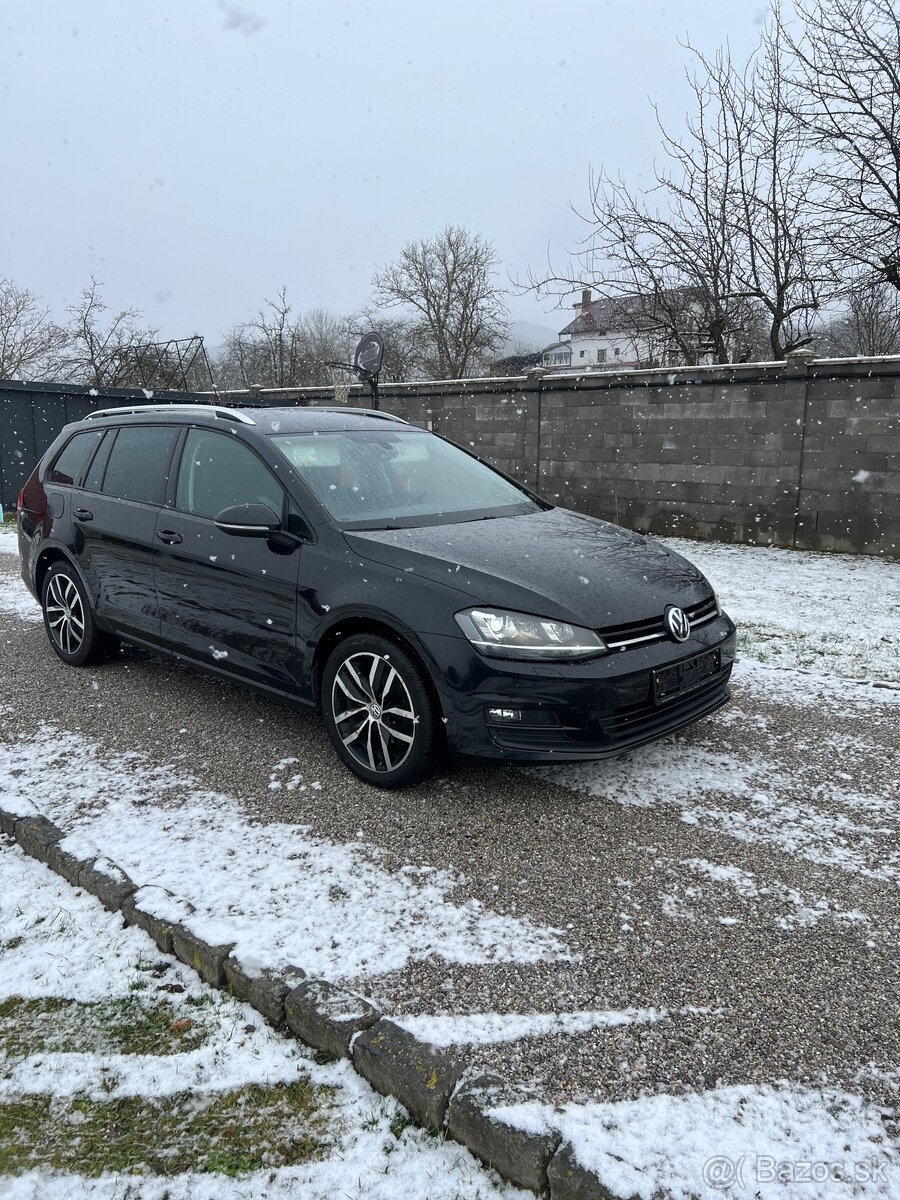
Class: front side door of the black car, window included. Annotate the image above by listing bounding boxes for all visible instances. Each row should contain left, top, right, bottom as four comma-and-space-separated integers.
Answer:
156, 427, 306, 692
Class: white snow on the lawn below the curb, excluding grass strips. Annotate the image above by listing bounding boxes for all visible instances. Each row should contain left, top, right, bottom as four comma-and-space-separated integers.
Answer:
0, 845, 533, 1200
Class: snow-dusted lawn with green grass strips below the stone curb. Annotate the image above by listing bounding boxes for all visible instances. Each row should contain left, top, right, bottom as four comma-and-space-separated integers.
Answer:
0, 845, 527, 1200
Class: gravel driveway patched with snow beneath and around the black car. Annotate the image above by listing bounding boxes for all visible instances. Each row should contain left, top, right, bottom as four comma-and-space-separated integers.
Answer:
0, 542, 900, 1200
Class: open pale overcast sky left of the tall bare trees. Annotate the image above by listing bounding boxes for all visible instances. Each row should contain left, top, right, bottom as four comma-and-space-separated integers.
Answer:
0, 0, 763, 344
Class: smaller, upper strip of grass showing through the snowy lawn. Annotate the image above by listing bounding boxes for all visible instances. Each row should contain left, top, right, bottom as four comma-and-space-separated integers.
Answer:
0, 992, 210, 1060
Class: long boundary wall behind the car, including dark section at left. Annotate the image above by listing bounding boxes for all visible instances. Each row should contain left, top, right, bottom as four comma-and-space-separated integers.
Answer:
0, 358, 900, 558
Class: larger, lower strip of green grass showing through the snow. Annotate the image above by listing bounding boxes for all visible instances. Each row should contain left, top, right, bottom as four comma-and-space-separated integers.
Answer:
0, 1079, 334, 1178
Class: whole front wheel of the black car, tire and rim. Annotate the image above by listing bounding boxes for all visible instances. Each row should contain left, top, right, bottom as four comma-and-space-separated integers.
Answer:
322, 634, 444, 788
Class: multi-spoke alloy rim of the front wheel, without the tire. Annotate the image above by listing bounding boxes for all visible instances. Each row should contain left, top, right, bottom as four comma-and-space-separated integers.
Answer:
331, 652, 419, 773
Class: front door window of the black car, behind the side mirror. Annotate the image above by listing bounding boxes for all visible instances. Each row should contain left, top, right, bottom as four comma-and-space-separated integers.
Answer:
175, 430, 284, 517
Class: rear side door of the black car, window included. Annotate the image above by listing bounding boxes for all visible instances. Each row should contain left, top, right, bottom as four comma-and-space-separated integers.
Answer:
72, 424, 179, 641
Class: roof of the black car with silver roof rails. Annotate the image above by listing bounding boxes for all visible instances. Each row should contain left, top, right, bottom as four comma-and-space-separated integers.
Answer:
84, 404, 408, 434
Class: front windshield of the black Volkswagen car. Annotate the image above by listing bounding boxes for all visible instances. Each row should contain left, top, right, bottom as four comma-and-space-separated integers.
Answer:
272, 430, 541, 529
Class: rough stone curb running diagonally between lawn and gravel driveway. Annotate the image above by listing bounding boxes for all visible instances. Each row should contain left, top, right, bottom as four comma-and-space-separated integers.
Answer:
0, 808, 614, 1200
